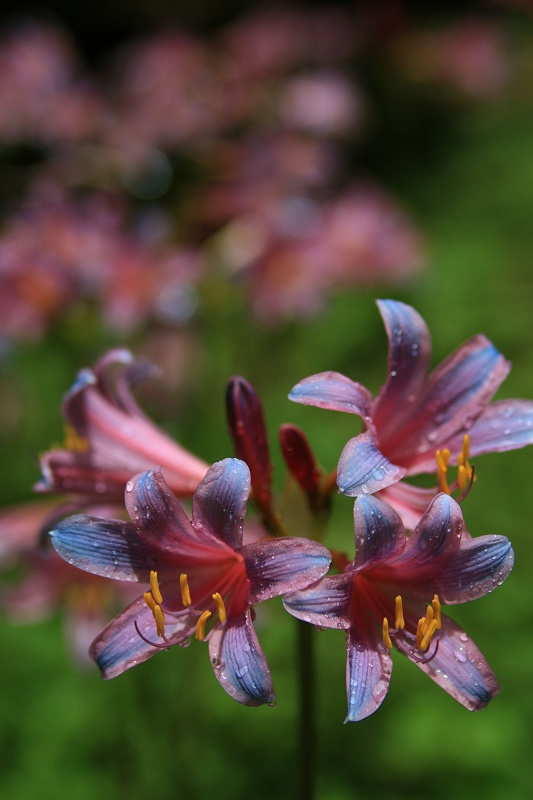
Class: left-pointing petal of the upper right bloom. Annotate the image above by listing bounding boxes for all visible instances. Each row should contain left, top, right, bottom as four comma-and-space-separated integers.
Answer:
289, 372, 372, 426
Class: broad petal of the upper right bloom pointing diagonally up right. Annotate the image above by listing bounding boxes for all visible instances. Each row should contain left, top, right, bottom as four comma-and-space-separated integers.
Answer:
380, 335, 510, 474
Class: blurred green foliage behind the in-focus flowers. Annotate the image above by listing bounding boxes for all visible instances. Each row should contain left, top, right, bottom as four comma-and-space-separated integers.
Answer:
0, 3, 533, 800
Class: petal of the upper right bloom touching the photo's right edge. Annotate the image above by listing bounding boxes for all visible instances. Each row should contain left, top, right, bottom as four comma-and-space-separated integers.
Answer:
446, 400, 533, 462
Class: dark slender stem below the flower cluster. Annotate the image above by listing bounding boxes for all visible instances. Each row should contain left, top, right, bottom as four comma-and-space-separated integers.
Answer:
295, 620, 316, 800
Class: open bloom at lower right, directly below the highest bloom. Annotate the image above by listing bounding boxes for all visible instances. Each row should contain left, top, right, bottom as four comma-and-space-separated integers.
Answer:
284, 493, 514, 722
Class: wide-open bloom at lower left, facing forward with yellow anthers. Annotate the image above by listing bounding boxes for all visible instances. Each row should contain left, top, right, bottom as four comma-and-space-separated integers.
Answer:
51, 458, 331, 706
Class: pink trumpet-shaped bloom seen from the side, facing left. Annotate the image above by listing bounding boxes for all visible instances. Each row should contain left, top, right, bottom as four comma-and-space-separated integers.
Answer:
35, 349, 208, 503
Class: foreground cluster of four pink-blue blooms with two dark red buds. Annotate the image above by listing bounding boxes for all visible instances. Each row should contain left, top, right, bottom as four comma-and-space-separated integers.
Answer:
0, 300, 533, 721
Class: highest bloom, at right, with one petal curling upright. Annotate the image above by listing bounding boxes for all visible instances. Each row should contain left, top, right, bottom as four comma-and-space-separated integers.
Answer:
289, 300, 533, 528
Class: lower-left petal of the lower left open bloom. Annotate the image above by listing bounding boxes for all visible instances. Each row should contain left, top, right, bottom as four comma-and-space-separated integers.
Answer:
89, 597, 197, 680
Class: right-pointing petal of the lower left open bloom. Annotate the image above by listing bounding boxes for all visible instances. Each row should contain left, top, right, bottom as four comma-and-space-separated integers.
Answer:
241, 536, 331, 605
